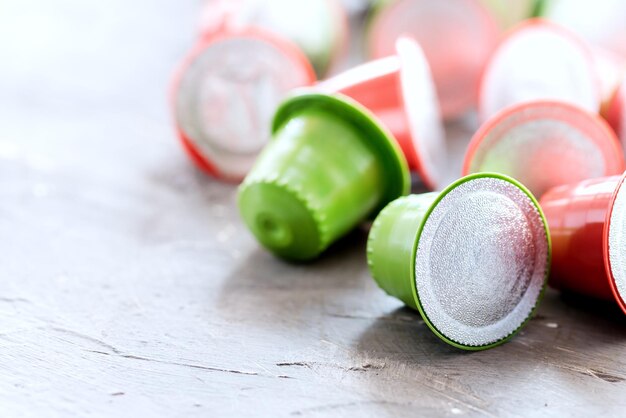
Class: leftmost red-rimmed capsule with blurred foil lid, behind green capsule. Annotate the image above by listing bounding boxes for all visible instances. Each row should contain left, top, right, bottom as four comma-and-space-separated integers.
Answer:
171, 29, 315, 181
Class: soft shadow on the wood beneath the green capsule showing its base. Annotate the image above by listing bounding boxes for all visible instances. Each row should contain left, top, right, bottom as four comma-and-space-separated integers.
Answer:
217, 229, 370, 328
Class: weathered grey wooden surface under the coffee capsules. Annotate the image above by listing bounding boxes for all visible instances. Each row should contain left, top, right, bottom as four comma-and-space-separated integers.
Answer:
0, 0, 626, 417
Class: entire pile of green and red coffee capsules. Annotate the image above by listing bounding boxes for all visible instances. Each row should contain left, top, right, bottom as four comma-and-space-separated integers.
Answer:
171, 0, 626, 350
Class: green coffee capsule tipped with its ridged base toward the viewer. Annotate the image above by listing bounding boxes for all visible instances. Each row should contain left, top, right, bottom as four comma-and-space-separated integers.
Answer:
238, 93, 410, 261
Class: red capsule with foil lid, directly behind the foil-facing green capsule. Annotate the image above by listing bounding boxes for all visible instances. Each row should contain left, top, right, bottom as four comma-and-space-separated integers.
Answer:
463, 100, 626, 196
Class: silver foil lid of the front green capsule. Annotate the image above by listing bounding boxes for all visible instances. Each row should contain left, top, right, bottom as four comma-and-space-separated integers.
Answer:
415, 177, 549, 347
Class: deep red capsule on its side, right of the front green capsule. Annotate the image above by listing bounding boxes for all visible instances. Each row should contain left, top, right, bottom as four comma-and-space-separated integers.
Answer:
540, 171, 626, 313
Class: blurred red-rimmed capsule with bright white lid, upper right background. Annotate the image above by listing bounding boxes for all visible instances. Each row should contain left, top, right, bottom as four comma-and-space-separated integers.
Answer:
479, 19, 601, 121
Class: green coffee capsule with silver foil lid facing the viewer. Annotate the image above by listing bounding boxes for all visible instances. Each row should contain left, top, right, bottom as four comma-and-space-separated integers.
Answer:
367, 173, 550, 350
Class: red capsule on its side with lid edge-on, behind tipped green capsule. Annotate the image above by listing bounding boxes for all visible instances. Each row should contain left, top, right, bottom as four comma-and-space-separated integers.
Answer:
317, 37, 447, 190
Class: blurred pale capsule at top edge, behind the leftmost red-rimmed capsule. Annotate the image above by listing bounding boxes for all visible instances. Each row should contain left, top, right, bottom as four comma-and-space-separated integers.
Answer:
201, 0, 348, 77
